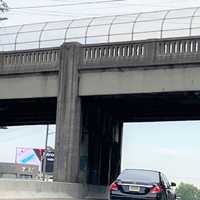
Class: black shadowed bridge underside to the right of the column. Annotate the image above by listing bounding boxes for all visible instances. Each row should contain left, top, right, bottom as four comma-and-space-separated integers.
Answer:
83, 91, 200, 122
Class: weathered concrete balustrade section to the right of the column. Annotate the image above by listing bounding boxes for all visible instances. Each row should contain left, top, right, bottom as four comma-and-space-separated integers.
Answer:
81, 37, 200, 69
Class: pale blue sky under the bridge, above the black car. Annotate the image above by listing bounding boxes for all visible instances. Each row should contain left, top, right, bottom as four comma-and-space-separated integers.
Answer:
122, 121, 200, 187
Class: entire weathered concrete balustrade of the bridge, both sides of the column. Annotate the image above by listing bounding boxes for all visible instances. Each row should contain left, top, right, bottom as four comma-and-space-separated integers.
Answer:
0, 37, 200, 74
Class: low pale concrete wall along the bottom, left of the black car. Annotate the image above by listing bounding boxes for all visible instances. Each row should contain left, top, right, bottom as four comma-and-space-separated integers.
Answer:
0, 179, 107, 200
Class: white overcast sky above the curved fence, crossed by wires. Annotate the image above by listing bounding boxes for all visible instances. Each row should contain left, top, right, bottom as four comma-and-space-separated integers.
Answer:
2, 0, 200, 26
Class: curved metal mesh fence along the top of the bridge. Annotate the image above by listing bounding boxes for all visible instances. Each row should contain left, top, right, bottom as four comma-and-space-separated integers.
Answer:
0, 7, 200, 51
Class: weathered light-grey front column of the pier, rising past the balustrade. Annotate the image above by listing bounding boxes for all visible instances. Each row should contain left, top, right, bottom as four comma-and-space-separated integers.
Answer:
54, 43, 82, 182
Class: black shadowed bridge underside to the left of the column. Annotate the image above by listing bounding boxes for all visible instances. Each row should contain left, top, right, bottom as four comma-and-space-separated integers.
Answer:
0, 98, 57, 126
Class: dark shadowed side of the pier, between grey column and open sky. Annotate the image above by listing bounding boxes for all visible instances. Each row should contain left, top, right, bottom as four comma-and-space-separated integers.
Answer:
82, 98, 123, 185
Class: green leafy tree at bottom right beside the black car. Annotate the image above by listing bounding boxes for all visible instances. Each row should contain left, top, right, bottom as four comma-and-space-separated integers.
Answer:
176, 183, 200, 200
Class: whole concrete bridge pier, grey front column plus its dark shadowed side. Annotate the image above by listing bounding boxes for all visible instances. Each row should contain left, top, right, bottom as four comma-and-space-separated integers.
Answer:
55, 43, 122, 185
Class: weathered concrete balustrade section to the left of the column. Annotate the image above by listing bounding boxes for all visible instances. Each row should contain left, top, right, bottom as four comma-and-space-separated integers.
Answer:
0, 48, 60, 73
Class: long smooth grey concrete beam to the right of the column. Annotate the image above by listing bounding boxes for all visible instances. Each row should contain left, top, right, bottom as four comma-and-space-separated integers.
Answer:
79, 66, 200, 96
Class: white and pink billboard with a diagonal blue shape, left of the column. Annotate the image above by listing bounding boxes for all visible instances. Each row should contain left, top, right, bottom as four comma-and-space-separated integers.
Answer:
15, 147, 44, 166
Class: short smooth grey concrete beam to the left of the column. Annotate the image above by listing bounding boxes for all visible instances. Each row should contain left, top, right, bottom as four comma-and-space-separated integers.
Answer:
0, 72, 58, 99
